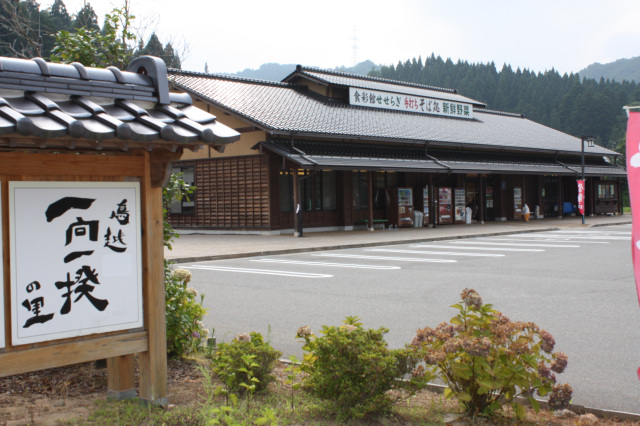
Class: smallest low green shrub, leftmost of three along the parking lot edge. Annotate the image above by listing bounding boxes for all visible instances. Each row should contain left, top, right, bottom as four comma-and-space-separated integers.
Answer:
211, 332, 282, 393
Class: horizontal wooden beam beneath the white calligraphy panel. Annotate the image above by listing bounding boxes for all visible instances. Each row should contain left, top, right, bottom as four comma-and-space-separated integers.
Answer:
0, 331, 146, 377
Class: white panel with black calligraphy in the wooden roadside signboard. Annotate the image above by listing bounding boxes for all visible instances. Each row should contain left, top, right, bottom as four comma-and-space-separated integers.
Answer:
9, 182, 143, 345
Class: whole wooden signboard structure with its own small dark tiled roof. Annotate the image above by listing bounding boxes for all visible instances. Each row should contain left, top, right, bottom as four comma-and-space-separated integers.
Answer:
0, 57, 239, 404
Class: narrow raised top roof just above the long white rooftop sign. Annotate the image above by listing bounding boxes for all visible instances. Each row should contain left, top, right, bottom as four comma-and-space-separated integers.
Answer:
283, 66, 485, 106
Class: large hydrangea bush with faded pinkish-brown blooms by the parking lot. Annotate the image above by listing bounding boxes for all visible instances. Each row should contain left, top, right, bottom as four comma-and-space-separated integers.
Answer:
412, 289, 571, 418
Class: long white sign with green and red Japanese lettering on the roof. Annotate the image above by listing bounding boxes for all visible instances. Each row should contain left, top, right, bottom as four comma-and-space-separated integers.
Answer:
349, 87, 473, 119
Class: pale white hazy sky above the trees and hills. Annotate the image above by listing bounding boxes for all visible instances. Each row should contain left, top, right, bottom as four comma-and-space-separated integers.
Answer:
40, 0, 640, 73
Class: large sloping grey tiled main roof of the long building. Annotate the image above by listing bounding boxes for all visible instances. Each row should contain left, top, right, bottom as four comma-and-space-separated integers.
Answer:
169, 70, 619, 156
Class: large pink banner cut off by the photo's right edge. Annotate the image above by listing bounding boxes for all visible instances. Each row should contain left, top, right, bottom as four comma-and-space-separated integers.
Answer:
627, 110, 640, 301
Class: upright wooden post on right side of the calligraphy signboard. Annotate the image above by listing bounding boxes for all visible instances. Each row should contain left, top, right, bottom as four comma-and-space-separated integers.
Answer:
138, 152, 168, 405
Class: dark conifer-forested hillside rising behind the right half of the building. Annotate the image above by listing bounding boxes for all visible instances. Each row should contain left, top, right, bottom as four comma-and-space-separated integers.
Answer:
369, 55, 640, 149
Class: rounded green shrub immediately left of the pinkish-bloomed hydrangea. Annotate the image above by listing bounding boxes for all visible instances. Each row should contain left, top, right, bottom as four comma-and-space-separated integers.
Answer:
298, 317, 402, 419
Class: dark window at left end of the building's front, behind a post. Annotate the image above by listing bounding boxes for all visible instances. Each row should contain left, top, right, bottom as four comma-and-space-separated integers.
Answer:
280, 170, 337, 213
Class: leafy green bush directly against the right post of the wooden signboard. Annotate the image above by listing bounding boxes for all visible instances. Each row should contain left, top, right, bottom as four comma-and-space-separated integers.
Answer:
164, 267, 207, 357
